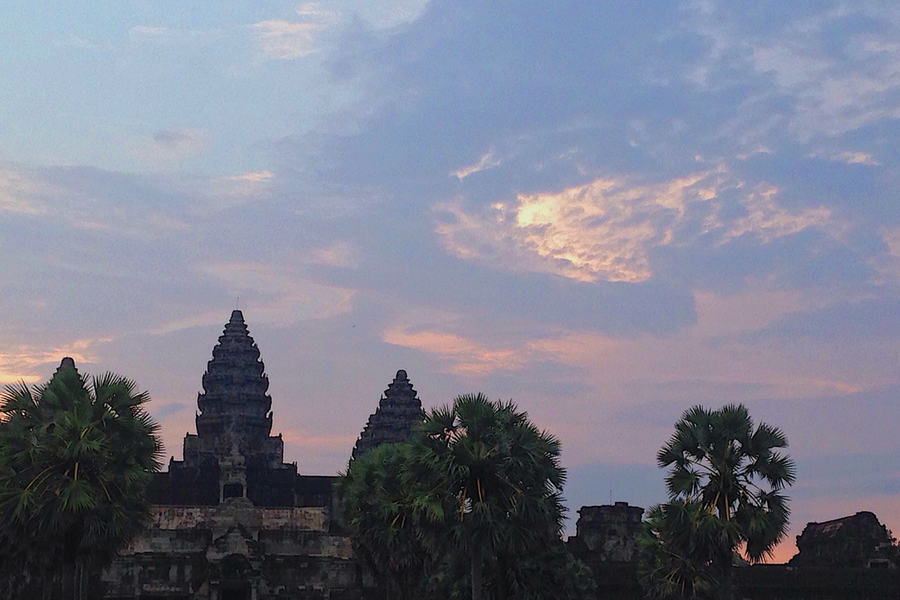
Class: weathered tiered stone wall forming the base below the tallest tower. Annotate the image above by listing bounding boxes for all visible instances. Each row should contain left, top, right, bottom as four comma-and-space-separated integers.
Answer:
92, 498, 361, 600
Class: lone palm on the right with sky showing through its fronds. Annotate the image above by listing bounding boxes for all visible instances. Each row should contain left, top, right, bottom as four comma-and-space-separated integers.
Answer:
657, 405, 796, 600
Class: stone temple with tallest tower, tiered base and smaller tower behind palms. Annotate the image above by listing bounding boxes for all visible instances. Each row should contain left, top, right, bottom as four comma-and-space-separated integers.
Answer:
96, 310, 422, 600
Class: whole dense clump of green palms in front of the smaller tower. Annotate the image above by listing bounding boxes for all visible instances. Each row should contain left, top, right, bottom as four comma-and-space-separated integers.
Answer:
337, 394, 594, 600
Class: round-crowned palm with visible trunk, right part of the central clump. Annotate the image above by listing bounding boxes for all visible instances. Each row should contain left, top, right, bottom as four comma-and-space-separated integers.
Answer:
406, 394, 565, 600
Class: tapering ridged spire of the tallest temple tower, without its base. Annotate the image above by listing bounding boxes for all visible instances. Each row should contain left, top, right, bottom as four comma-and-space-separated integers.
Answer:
197, 310, 272, 440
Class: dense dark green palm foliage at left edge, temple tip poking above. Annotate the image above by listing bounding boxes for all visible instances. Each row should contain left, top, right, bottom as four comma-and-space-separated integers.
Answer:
0, 358, 162, 598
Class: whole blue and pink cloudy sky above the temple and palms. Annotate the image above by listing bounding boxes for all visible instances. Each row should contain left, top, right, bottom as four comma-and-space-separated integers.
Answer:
0, 0, 900, 560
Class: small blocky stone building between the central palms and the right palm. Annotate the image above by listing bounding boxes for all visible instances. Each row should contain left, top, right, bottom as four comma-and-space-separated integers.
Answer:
568, 502, 644, 563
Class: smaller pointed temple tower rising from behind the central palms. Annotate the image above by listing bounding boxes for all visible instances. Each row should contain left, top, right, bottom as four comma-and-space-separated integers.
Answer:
352, 369, 424, 458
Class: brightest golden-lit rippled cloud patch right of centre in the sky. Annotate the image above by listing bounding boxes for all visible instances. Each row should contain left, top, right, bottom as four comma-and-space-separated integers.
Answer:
435, 167, 834, 282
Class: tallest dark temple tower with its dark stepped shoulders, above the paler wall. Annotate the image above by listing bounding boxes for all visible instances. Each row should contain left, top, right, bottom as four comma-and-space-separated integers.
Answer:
150, 310, 333, 508
